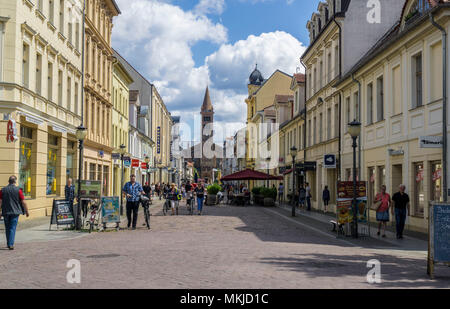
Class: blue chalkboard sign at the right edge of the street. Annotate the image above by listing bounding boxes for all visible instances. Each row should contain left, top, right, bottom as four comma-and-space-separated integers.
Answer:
430, 204, 450, 263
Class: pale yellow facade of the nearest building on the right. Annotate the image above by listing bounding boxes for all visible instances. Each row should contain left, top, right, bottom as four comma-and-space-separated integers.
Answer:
337, 1, 450, 232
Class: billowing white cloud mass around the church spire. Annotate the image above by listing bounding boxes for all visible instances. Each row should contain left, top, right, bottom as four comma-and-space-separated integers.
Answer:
113, 0, 304, 143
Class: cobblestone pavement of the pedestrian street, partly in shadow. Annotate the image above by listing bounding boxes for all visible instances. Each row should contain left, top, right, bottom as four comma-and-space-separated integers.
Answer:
0, 201, 450, 289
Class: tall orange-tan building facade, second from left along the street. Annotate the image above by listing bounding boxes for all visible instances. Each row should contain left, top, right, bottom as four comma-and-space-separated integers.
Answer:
83, 0, 120, 196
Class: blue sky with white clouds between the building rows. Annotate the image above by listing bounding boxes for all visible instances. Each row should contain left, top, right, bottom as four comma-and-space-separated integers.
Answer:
112, 0, 319, 142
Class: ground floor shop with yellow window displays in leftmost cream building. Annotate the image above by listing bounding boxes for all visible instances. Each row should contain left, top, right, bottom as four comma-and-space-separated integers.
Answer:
0, 112, 78, 218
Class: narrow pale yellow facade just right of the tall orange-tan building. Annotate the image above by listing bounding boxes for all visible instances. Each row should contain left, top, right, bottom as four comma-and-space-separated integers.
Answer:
111, 61, 133, 196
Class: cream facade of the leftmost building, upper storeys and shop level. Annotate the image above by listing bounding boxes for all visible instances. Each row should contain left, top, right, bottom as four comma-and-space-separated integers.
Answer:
0, 0, 82, 218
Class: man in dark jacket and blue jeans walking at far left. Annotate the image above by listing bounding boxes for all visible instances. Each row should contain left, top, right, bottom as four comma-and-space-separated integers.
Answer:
0, 176, 30, 250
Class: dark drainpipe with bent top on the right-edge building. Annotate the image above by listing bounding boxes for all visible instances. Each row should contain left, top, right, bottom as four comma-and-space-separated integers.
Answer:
430, 12, 448, 202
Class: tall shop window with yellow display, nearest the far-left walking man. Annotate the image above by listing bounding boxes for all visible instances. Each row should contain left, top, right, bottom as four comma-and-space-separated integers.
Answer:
19, 126, 33, 197
